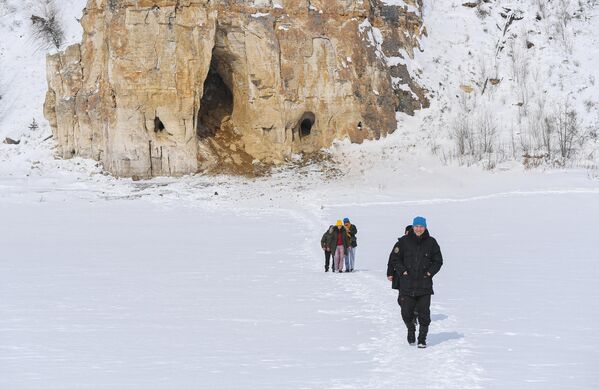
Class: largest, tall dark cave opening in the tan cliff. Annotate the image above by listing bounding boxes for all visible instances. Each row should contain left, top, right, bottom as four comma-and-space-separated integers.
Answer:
196, 55, 233, 139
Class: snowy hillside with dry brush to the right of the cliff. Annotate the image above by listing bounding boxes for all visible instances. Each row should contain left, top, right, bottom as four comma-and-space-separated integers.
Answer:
400, 0, 599, 168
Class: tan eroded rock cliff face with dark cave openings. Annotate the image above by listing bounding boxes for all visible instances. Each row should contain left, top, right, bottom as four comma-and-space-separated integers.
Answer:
45, 0, 426, 177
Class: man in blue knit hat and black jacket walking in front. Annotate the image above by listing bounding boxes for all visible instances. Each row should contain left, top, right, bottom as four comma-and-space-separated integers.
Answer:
389, 216, 443, 348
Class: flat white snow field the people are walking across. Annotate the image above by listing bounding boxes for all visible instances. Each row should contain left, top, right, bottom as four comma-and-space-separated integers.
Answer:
0, 161, 599, 389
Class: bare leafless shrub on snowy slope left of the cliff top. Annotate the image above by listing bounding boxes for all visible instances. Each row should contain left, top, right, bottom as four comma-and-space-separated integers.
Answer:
31, 0, 65, 49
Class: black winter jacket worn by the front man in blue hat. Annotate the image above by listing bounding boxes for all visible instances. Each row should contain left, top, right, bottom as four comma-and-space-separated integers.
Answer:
387, 230, 443, 296
